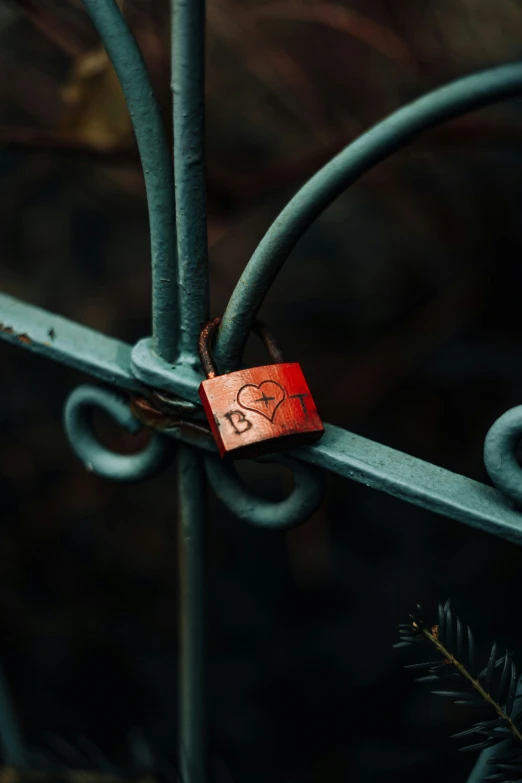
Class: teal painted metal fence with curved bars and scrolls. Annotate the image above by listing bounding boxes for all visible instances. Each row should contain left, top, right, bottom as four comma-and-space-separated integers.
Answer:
0, 0, 522, 783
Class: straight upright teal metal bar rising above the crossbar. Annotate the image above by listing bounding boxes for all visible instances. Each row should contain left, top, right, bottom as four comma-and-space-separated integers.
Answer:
171, 0, 209, 364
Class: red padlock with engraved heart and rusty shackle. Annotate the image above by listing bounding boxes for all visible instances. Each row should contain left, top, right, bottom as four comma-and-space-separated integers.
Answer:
199, 318, 324, 458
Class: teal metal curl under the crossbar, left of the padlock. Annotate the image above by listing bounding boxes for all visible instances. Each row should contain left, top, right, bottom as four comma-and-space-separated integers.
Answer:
64, 385, 170, 482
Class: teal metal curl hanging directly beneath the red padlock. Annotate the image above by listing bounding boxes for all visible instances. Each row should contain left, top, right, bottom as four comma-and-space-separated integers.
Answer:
205, 454, 325, 530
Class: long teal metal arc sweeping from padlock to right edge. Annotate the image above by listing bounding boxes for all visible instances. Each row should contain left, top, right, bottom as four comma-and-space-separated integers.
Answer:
214, 63, 522, 372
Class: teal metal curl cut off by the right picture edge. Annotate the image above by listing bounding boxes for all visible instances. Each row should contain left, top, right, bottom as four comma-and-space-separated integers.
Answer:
484, 405, 522, 508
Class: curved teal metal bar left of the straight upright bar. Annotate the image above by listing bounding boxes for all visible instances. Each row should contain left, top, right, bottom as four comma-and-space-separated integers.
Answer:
83, 0, 179, 362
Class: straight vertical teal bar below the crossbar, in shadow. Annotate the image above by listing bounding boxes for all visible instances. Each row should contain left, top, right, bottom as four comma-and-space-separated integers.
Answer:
178, 443, 207, 783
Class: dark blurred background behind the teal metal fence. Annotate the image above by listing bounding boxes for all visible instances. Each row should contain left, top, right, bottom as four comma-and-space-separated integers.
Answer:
0, 0, 522, 783
